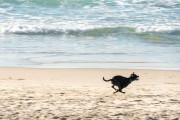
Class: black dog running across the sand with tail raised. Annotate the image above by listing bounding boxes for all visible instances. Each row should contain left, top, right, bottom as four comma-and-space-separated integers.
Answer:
103, 72, 139, 93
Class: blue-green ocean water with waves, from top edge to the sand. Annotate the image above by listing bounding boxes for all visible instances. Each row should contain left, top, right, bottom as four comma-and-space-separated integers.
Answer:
0, 0, 180, 70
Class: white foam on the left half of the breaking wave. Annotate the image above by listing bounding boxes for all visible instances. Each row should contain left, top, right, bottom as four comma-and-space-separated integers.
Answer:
0, 22, 100, 34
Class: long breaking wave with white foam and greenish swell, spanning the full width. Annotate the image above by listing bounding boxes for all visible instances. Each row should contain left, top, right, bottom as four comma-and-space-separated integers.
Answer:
0, 24, 180, 36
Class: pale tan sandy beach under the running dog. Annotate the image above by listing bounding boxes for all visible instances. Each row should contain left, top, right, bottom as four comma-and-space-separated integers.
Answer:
0, 68, 180, 120
